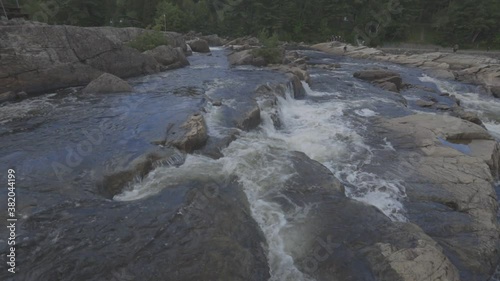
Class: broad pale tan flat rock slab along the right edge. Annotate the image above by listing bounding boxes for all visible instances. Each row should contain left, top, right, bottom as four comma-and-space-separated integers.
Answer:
380, 114, 500, 280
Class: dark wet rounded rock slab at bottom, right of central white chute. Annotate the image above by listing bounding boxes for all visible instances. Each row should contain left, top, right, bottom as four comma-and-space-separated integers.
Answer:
268, 153, 459, 281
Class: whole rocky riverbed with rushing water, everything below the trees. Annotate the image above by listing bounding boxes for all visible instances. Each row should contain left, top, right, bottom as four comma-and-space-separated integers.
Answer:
0, 22, 500, 281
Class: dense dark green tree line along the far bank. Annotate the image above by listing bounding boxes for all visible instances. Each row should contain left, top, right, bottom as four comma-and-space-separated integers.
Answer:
15, 0, 500, 48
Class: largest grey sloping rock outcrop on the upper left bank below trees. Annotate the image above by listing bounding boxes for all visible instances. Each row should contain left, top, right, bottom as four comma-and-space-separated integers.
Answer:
0, 25, 160, 94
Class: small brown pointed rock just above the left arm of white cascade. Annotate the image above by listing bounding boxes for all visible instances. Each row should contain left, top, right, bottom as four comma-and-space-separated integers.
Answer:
167, 114, 208, 153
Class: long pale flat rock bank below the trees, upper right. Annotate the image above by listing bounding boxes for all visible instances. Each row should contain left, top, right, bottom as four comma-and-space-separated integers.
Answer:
311, 42, 500, 98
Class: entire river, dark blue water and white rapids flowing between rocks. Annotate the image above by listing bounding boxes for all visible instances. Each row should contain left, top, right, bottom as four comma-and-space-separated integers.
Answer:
0, 48, 500, 281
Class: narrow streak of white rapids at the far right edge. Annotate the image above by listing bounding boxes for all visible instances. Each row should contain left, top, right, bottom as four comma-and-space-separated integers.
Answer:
420, 75, 500, 139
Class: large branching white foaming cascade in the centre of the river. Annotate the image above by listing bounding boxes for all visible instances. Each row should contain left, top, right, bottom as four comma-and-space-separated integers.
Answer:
115, 79, 406, 281
